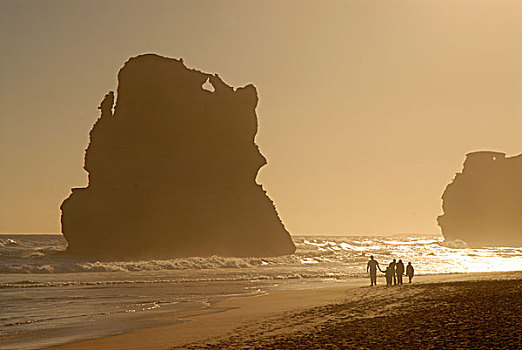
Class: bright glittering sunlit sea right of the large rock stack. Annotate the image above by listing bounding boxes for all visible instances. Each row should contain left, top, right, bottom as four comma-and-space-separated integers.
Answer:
296, 237, 522, 274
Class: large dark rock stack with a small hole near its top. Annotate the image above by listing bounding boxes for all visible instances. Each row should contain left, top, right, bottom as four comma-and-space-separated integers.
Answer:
61, 54, 295, 258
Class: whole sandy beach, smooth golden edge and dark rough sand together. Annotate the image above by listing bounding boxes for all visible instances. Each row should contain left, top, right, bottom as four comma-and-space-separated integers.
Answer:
47, 272, 522, 350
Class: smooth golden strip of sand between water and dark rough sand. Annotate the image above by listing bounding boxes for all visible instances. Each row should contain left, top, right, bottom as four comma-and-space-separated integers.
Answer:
48, 271, 522, 350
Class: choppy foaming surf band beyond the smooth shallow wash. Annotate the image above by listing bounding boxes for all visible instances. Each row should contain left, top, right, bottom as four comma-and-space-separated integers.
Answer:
0, 235, 522, 278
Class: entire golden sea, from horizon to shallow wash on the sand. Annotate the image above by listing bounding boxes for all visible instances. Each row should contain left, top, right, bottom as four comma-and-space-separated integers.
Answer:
0, 234, 522, 349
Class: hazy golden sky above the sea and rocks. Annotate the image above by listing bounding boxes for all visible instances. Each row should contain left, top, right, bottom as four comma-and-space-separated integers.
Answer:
0, 0, 522, 235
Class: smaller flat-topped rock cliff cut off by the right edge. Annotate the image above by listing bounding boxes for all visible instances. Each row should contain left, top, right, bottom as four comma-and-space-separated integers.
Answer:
438, 152, 522, 246
